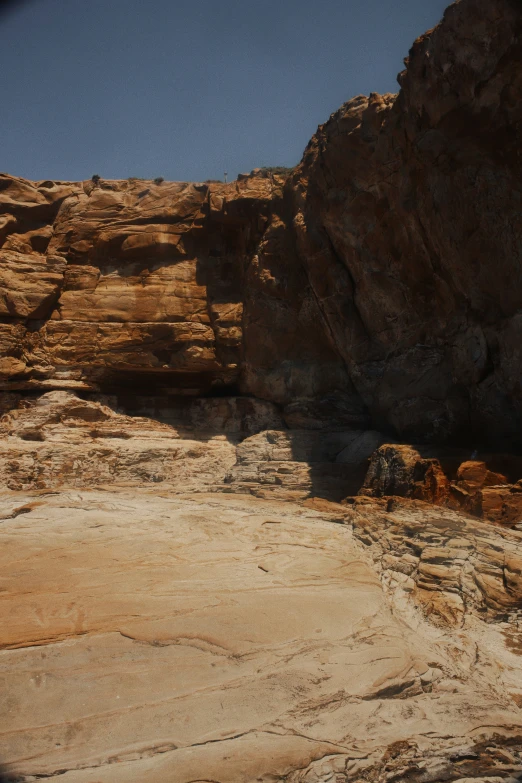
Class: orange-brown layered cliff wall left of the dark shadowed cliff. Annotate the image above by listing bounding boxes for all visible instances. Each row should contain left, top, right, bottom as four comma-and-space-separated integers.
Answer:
0, 174, 354, 424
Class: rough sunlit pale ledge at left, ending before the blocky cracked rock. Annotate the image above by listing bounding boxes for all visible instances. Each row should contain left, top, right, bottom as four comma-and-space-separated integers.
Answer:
0, 391, 236, 492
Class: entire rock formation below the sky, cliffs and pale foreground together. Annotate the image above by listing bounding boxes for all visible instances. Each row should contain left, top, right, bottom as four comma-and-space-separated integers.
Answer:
0, 0, 522, 783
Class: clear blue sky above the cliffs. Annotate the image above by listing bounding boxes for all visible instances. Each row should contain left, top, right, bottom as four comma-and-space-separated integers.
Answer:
0, 0, 448, 181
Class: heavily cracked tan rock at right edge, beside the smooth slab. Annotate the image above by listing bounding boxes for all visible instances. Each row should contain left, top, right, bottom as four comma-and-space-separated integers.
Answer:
349, 498, 522, 628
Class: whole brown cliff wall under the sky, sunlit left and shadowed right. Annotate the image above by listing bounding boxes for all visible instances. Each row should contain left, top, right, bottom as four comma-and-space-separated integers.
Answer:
0, 0, 522, 448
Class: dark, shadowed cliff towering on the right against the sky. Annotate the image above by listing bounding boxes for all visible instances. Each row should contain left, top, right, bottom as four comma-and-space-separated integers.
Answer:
294, 0, 522, 445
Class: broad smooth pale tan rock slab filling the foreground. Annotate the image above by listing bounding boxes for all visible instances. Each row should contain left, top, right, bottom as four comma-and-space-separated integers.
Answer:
0, 489, 522, 783
